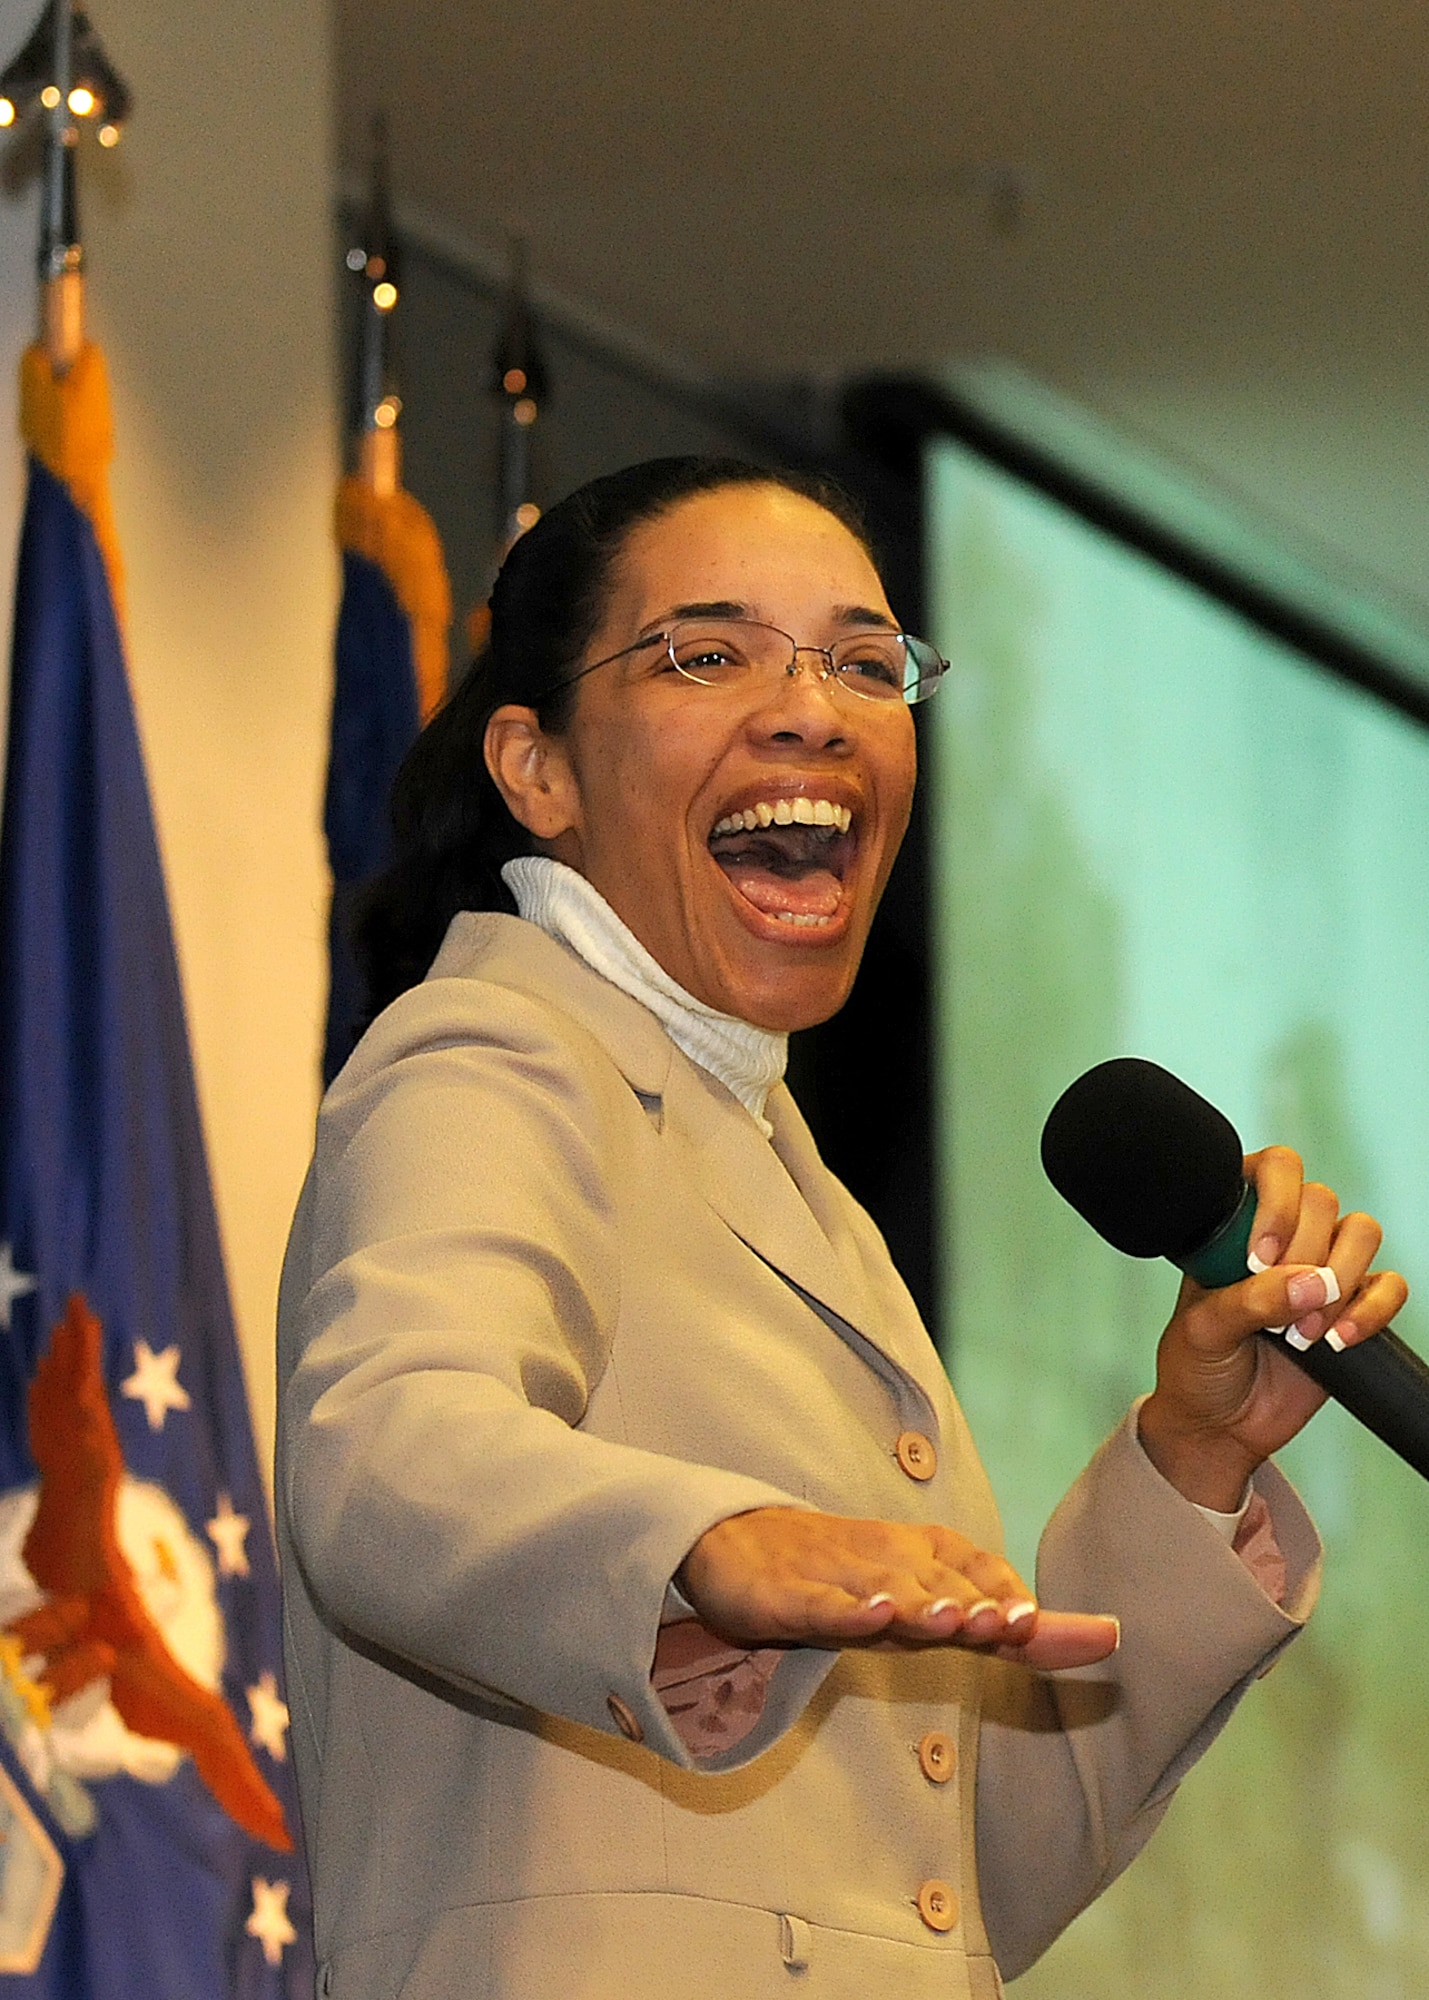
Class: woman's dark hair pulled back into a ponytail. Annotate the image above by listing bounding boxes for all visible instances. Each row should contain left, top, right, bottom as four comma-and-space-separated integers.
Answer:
354, 458, 877, 1018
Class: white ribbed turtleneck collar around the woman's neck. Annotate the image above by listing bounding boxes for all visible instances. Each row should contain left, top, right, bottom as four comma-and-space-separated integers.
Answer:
500, 854, 789, 1138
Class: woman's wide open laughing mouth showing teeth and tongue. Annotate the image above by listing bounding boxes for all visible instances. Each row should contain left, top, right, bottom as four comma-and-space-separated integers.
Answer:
708, 798, 859, 930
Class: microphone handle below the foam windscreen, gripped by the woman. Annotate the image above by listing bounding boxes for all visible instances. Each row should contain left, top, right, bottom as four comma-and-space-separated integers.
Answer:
1173, 1184, 1429, 1480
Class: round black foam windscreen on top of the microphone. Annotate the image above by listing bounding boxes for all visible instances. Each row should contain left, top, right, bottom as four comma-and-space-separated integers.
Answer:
1043, 1056, 1245, 1264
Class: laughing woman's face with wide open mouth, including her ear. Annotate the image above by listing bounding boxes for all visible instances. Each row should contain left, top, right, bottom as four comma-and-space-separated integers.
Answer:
488, 486, 917, 1028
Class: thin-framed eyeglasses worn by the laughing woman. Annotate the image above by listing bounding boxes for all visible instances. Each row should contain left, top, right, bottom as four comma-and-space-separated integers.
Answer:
550, 618, 949, 704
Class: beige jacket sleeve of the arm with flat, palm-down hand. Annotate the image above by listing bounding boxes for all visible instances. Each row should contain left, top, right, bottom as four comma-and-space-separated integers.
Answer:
278, 988, 835, 1768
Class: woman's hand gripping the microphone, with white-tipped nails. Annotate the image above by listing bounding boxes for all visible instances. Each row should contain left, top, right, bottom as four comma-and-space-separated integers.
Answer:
1141, 1146, 1409, 1514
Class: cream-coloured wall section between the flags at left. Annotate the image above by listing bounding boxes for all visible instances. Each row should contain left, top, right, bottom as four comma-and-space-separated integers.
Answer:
0, 0, 336, 1464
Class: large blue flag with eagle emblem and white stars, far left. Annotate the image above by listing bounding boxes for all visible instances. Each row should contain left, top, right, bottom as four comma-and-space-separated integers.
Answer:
0, 348, 312, 2000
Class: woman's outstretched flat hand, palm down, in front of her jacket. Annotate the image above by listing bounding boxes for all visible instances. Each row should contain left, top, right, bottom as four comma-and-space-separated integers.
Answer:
676, 1508, 1121, 1670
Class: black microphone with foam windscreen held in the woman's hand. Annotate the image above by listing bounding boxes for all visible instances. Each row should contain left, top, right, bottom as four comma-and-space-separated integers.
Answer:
1043, 1056, 1429, 1478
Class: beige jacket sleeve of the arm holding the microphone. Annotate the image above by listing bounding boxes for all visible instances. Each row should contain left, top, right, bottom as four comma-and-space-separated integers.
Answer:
977, 1410, 1321, 1978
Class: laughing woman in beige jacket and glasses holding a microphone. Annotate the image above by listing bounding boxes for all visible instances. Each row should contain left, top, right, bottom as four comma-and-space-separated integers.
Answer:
278, 460, 1405, 2000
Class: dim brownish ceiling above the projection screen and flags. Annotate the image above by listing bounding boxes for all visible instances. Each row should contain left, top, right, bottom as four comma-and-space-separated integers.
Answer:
336, 0, 1429, 616
